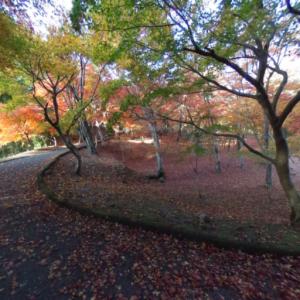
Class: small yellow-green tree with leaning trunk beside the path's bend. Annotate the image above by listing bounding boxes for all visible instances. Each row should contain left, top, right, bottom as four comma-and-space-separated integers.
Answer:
20, 31, 90, 175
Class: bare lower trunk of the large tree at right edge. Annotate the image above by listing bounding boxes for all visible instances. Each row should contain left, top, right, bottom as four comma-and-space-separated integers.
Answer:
274, 129, 300, 226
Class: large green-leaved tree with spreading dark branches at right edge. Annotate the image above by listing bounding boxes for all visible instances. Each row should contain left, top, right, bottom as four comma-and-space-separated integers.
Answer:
74, 0, 300, 225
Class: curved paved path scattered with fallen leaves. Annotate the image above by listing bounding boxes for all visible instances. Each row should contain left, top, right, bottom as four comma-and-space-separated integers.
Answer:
0, 150, 300, 300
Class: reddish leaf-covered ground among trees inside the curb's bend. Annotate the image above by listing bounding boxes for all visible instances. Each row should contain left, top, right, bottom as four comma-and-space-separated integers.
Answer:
46, 139, 300, 224
